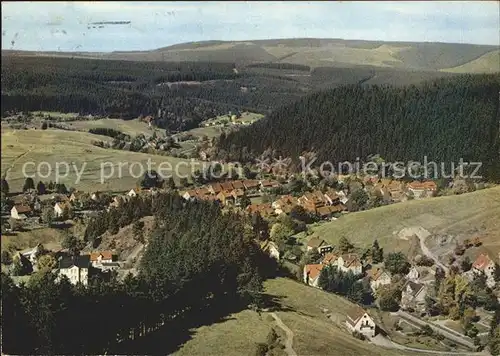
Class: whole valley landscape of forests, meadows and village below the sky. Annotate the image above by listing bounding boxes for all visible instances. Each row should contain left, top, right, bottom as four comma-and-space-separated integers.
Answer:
1, 13, 500, 356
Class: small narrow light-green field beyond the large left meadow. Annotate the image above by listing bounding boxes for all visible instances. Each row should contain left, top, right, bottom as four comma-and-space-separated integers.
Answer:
67, 119, 155, 137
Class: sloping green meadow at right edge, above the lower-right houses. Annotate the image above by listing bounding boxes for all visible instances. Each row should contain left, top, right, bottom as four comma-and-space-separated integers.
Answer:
313, 187, 500, 253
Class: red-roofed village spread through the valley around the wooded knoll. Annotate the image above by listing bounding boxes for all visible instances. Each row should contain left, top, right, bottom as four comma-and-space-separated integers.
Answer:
2, 170, 500, 349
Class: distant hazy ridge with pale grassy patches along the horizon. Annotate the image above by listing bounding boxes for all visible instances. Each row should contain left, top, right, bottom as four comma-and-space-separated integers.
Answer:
2, 38, 498, 72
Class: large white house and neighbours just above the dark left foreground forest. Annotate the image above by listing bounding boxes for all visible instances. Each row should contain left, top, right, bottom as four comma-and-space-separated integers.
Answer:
20, 244, 120, 286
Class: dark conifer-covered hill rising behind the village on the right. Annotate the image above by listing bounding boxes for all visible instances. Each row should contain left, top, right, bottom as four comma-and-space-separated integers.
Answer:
219, 75, 500, 178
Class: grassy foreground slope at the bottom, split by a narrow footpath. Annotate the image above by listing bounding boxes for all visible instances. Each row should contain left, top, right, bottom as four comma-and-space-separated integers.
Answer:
176, 278, 424, 356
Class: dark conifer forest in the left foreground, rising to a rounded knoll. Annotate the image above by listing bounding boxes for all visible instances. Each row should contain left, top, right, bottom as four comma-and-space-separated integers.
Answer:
1, 194, 276, 355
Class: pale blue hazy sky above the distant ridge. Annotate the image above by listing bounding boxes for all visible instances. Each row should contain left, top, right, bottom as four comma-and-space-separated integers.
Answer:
2, 1, 500, 52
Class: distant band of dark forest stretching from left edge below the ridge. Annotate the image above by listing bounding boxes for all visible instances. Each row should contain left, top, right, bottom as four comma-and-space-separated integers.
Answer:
2, 55, 458, 131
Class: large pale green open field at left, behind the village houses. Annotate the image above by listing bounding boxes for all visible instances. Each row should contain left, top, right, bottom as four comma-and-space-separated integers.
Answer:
2, 129, 201, 191
